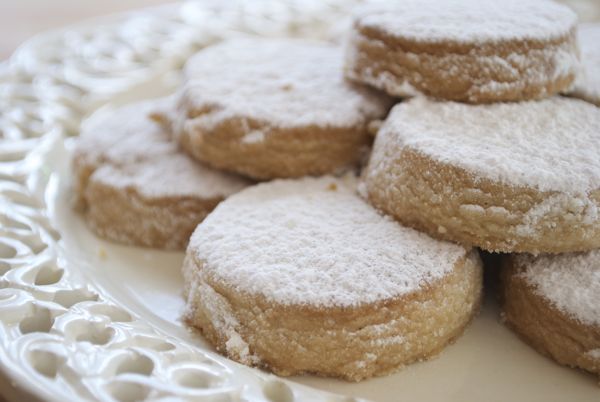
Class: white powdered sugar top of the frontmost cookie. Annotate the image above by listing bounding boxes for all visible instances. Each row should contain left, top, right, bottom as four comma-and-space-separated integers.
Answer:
188, 177, 467, 307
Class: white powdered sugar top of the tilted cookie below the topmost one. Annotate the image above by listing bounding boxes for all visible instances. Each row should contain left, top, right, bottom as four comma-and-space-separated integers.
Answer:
371, 97, 600, 195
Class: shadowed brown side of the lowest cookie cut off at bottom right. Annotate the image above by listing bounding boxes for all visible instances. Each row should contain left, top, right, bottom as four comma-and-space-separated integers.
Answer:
501, 256, 600, 375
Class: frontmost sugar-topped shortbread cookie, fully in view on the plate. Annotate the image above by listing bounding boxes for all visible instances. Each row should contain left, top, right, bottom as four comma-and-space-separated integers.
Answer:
184, 177, 482, 381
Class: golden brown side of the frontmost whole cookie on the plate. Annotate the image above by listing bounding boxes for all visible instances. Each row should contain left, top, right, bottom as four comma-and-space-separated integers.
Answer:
184, 251, 482, 381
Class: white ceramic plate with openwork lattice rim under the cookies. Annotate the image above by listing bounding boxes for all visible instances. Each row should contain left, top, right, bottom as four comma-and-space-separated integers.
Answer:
0, 0, 600, 402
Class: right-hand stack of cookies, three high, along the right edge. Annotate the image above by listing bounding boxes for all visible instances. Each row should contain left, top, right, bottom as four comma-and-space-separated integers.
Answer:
347, 0, 600, 380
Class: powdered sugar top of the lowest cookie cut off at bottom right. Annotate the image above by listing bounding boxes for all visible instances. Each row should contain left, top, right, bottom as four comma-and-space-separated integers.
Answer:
515, 250, 600, 325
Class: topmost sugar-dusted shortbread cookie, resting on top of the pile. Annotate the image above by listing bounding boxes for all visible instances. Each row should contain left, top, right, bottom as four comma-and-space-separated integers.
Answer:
346, 0, 578, 103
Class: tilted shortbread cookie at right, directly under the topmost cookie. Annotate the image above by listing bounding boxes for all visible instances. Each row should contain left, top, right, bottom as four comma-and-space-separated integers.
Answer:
365, 97, 600, 253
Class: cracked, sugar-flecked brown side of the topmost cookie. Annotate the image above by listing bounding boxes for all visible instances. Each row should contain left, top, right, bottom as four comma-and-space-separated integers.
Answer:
345, 25, 580, 103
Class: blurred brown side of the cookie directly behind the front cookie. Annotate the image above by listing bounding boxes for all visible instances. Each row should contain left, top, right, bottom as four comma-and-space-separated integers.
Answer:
176, 110, 372, 180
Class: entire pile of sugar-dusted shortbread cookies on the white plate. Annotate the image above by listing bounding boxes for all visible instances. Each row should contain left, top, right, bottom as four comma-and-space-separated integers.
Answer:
75, 0, 600, 380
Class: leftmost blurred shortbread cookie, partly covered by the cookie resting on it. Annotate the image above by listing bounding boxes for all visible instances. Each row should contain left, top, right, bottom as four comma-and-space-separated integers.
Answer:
74, 101, 248, 249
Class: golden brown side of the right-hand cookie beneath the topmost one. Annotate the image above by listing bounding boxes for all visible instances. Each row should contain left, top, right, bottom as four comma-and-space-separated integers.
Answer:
365, 147, 600, 253
